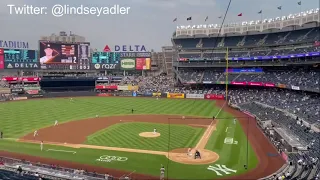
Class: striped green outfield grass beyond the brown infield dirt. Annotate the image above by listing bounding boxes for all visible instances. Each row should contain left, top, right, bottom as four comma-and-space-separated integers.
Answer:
0, 97, 218, 138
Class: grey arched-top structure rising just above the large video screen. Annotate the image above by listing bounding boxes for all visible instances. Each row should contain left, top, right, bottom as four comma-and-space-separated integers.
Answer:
40, 31, 86, 43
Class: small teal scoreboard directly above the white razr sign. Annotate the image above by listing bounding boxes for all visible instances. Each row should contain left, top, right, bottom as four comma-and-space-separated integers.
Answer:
92, 52, 120, 64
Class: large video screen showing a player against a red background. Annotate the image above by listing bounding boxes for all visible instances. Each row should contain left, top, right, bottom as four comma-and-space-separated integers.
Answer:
39, 41, 78, 64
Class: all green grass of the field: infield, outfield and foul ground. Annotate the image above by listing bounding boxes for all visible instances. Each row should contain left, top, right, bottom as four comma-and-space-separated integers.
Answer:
0, 97, 257, 179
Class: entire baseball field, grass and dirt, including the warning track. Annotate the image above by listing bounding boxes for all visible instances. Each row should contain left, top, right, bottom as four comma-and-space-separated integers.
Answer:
0, 97, 283, 179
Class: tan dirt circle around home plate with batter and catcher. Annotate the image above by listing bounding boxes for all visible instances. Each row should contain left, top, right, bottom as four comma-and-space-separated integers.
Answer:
167, 148, 219, 165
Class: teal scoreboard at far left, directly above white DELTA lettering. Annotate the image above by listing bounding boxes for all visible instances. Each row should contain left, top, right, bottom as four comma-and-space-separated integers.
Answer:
4, 49, 39, 63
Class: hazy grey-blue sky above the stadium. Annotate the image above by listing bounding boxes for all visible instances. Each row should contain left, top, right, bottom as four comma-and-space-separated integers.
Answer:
0, 0, 319, 51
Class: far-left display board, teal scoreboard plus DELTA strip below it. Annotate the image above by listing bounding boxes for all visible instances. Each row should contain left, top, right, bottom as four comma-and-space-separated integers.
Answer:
3, 49, 40, 69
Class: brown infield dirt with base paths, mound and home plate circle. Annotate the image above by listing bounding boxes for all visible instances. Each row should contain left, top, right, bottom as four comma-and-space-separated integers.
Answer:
20, 115, 219, 164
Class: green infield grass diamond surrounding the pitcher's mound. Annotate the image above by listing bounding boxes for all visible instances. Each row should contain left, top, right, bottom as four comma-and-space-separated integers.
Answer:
86, 122, 204, 151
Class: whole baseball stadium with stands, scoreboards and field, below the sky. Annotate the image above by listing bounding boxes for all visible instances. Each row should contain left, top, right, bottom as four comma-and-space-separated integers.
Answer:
0, 2, 320, 180
